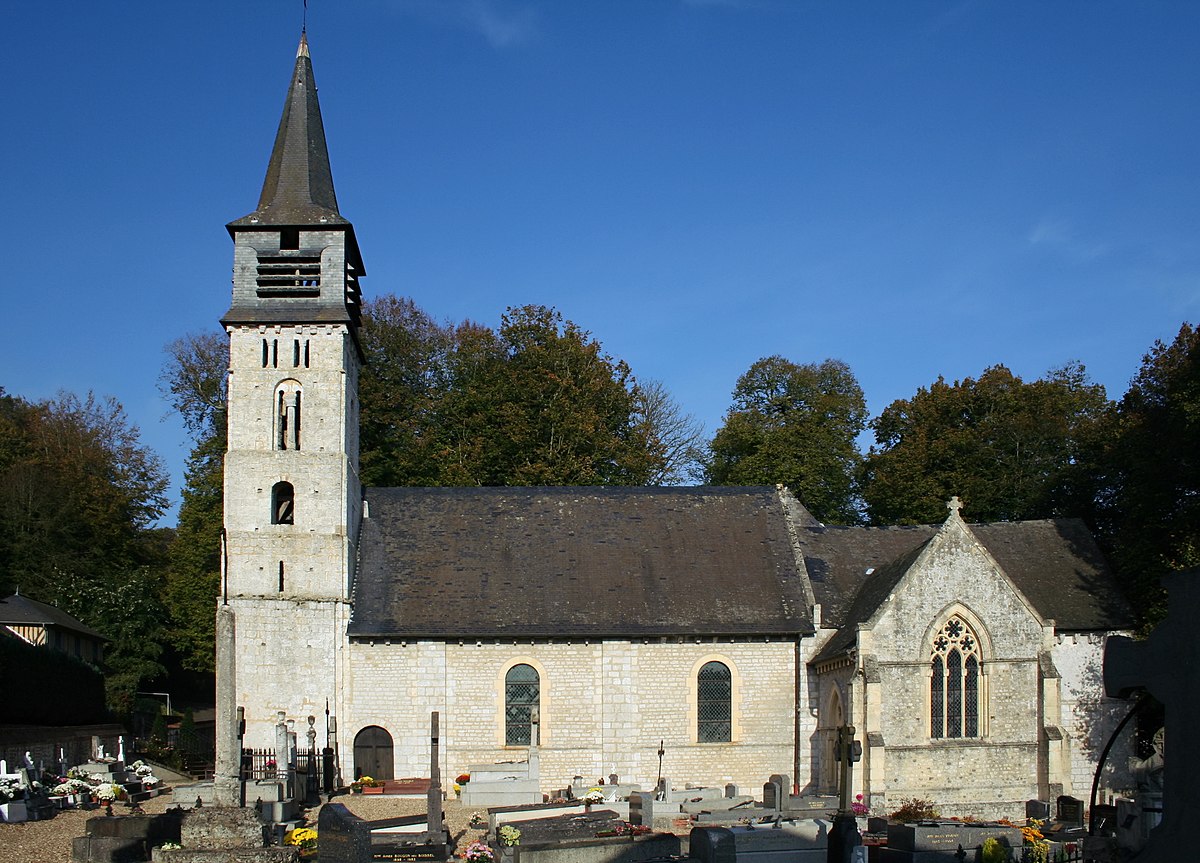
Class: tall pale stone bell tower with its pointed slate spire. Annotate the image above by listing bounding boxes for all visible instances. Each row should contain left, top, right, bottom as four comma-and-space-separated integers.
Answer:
218, 36, 364, 747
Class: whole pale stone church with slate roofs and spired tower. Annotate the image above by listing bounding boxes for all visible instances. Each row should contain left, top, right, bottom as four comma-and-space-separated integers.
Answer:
217, 37, 1132, 817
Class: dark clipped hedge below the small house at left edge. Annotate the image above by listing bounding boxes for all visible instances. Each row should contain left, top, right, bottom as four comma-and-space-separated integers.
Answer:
0, 639, 108, 725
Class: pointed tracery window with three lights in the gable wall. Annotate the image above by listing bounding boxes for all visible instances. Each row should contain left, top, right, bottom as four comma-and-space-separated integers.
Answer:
929, 615, 980, 739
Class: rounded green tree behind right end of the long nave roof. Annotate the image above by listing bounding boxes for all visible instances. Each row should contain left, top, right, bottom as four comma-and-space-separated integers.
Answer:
706, 355, 866, 525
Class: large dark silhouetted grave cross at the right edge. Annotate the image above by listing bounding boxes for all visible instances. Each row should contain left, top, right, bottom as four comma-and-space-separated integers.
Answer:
1104, 570, 1200, 863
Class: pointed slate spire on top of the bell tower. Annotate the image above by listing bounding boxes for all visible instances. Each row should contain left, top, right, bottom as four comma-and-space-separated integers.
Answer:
232, 34, 346, 226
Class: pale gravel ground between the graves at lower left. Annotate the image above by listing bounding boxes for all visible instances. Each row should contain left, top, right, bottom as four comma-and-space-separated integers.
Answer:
0, 793, 487, 863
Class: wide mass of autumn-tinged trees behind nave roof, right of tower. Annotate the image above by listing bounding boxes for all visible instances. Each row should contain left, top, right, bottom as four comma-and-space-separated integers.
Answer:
360, 296, 667, 486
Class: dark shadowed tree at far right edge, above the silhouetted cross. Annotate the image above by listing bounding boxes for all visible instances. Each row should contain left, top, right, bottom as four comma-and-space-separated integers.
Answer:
1097, 323, 1200, 627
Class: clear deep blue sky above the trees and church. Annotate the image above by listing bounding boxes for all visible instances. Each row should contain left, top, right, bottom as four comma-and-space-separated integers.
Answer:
0, 0, 1200, 522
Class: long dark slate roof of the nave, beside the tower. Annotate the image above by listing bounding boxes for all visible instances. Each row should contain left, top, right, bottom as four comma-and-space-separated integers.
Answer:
349, 487, 814, 640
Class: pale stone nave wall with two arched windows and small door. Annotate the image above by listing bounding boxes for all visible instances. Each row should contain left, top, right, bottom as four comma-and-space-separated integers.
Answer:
341, 641, 796, 791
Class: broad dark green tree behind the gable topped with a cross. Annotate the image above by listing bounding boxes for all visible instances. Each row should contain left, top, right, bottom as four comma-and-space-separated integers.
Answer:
863, 364, 1110, 525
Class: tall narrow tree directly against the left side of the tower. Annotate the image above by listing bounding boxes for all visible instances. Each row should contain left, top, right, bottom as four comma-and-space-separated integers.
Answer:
158, 332, 229, 673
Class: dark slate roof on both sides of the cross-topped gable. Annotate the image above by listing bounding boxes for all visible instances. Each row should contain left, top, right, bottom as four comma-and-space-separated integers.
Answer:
799, 519, 1133, 661
